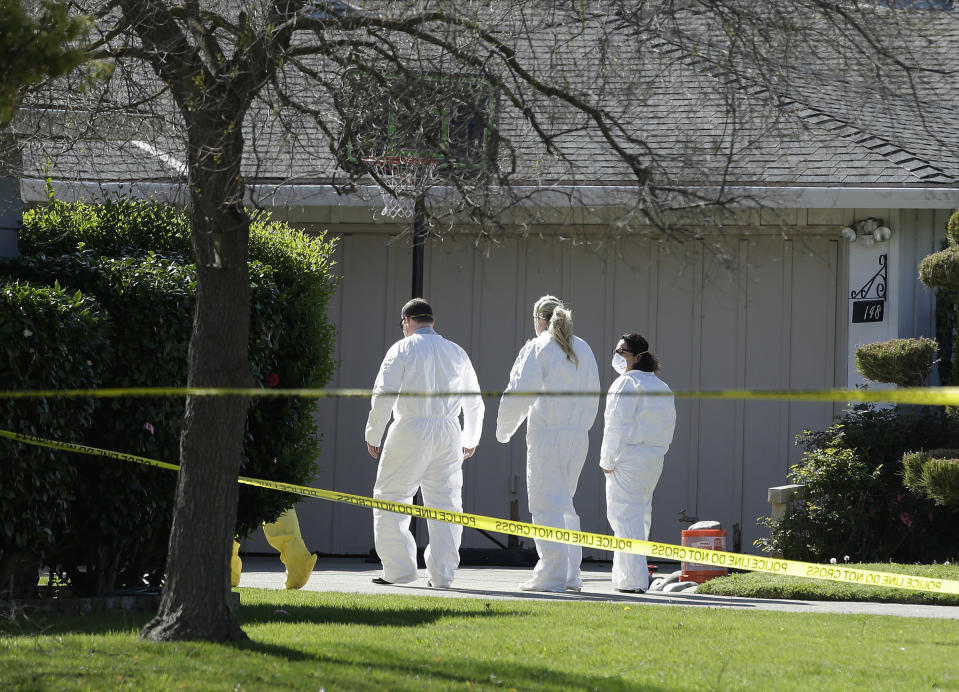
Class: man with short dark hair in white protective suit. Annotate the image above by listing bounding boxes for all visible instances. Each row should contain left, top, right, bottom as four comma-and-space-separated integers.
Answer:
366, 298, 484, 588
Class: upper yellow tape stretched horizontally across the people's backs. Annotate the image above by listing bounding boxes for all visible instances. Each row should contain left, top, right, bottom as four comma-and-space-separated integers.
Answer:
0, 387, 959, 406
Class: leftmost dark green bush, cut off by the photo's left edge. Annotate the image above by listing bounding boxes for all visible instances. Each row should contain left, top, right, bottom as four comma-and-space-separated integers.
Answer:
0, 282, 109, 595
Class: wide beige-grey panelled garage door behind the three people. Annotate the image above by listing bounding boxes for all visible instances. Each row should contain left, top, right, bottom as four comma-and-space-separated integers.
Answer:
272, 228, 844, 557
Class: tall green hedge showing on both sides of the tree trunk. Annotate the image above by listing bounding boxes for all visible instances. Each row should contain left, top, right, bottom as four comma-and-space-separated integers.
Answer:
0, 201, 333, 592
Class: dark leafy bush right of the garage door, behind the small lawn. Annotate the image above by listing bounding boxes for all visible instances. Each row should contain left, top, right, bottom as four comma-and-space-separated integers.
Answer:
757, 406, 959, 562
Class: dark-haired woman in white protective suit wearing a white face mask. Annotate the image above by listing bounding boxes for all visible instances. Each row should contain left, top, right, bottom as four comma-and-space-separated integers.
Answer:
599, 334, 676, 593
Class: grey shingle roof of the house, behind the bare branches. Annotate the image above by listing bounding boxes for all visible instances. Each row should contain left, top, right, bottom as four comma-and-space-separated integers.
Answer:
13, 4, 959, 195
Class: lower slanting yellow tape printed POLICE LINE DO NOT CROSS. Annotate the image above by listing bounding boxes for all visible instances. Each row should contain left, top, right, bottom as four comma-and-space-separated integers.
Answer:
0, 430, 959, 594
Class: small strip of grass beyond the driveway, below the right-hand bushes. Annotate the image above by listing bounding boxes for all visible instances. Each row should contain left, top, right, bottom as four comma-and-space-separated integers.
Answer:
696, 562, 959, 606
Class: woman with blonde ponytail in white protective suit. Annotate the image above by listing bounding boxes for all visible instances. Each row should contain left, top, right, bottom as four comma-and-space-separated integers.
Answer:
496, 296, 599, 591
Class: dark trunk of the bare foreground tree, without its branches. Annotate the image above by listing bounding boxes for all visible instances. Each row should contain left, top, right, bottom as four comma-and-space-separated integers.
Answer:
140, 109, 253, 641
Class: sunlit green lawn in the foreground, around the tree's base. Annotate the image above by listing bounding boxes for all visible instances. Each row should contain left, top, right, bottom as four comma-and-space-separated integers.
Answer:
0, 589, 959, 691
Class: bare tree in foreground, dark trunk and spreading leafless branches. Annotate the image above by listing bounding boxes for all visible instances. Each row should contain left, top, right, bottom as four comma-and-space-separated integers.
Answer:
24, 0, 952, 641
